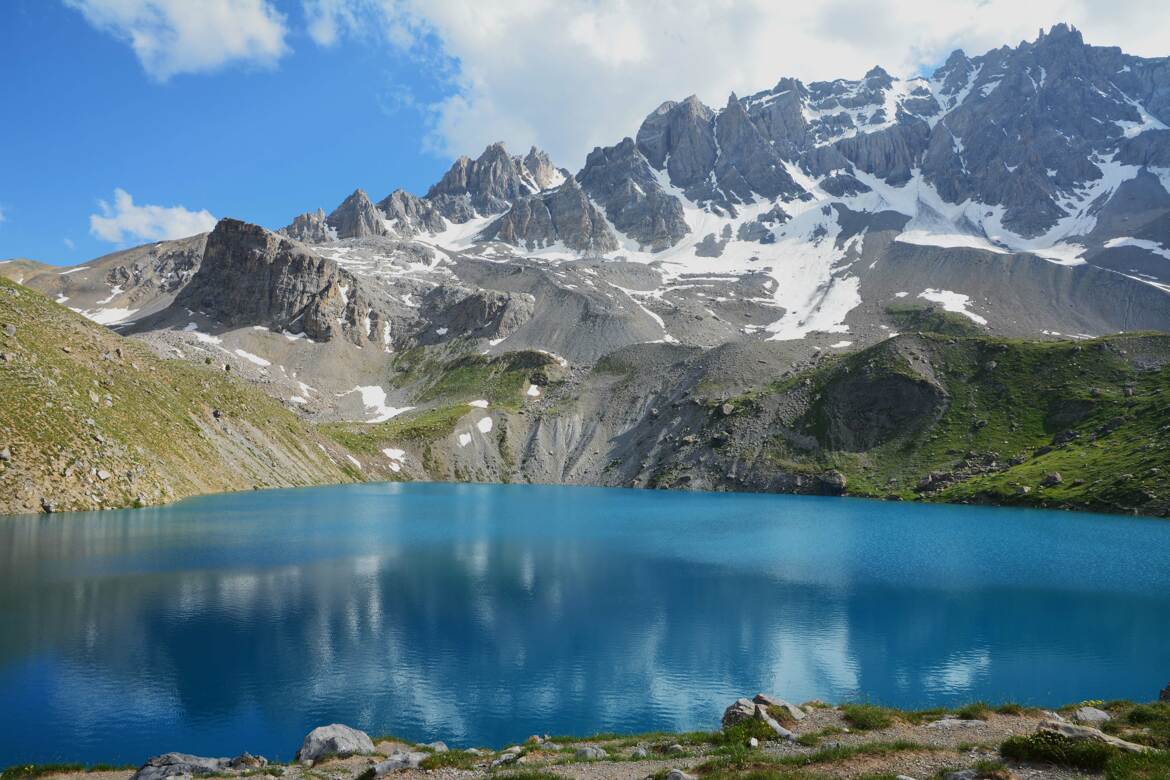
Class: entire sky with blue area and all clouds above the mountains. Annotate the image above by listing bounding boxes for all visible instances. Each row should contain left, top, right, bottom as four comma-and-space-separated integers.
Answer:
0, 0, 1170, 263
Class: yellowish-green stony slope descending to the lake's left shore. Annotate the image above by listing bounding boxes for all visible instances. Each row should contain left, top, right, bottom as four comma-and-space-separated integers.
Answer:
0, 279, 358, 511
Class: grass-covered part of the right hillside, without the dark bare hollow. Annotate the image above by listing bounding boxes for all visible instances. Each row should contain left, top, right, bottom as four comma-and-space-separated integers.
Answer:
744, 333, 1170, 515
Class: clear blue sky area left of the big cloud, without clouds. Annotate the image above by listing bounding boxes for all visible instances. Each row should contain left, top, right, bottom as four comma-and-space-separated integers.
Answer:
0, 0, 449, 263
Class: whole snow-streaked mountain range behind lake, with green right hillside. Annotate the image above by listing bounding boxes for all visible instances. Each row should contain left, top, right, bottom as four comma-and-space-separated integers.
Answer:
0, 25, 1170, 513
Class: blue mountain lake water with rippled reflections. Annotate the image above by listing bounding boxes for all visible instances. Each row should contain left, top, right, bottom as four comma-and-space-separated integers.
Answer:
0, 484, 1170, 766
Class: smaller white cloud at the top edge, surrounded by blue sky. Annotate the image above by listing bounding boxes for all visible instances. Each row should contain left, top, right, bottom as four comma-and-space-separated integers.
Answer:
64, 0, 289, 81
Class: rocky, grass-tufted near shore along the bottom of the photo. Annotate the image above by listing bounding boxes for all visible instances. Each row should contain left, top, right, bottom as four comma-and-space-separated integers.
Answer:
0, 685, 1170, 780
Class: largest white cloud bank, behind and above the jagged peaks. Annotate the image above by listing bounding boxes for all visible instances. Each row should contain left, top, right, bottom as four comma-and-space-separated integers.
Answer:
304, 0, 1170, 168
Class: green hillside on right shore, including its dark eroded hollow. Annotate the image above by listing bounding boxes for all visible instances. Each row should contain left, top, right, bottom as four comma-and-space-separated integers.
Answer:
692, 333, 1170, 516
